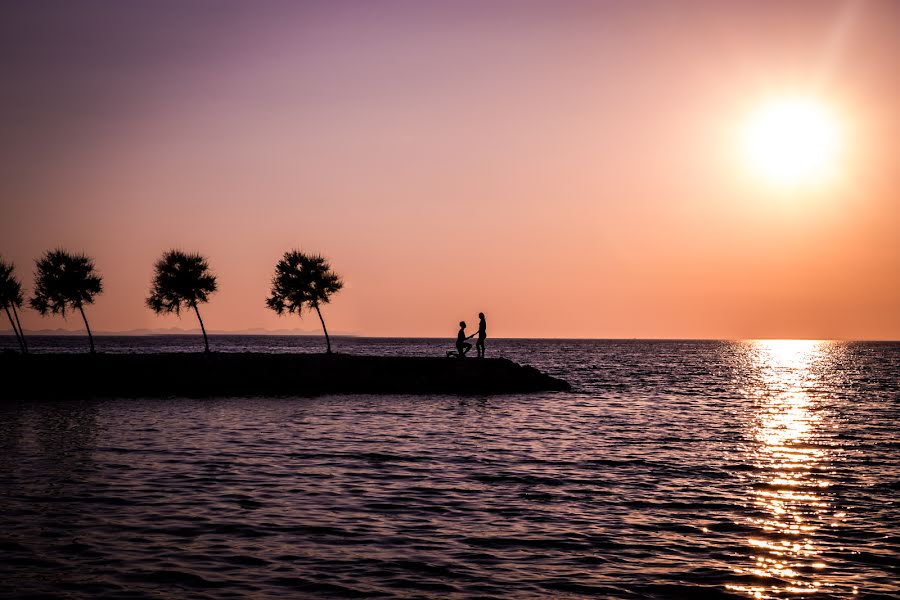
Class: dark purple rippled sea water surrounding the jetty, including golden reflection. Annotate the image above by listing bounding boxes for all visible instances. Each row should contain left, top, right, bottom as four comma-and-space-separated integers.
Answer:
0, 336, 900, 598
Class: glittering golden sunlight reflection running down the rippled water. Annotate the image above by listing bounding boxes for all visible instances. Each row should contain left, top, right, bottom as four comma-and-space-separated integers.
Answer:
728, 340, 858, 598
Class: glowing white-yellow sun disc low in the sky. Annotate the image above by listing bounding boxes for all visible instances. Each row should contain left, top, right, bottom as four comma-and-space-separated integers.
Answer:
743, 97, 840, 185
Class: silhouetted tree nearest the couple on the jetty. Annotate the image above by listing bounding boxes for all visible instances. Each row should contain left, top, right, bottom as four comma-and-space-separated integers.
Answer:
266, 250, 344, 354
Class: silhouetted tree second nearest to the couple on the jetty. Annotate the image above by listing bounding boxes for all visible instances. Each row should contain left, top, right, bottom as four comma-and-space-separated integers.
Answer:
147, 250, 217, 352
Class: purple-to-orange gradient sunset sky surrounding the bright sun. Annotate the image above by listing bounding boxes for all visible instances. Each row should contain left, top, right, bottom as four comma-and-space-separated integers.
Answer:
0, 0, 900, 339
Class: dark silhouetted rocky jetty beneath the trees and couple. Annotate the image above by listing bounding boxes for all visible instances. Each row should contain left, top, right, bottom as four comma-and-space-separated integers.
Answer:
0, 352, 571, 400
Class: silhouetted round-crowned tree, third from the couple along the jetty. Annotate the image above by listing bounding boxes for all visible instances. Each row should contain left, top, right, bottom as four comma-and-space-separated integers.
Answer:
31, 249, 103, 354
